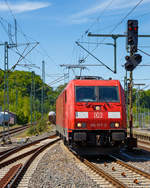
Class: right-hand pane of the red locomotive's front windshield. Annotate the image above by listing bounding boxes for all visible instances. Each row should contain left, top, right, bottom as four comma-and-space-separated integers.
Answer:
99, 86, 119, 102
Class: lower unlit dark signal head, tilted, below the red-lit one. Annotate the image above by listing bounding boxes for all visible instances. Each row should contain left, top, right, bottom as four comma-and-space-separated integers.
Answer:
125, 54, 142, 71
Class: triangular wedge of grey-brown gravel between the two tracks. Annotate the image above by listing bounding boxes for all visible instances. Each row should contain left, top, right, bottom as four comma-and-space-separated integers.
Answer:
29, 144, 99, 188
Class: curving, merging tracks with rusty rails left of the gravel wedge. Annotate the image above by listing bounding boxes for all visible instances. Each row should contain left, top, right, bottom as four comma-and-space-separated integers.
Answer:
0, 136, 60, 188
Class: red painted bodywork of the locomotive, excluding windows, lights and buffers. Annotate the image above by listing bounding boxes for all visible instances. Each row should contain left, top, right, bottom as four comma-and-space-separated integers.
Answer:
56, 80, 126, 138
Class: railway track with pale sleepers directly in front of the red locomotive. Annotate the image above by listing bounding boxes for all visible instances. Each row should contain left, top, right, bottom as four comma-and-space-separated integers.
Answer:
64, 144, 150, 188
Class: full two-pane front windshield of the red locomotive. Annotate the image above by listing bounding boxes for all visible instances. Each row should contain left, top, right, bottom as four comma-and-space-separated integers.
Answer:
76, 86, 119, 102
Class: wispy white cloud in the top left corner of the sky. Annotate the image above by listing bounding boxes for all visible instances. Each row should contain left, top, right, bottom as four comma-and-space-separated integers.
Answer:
0, 1, 51, 13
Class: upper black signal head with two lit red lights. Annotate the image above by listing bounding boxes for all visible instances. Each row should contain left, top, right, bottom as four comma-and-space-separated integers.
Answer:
127, 20, 138, 53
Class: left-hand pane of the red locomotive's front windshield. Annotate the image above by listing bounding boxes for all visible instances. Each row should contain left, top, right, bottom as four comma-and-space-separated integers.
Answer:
76, 86, 96, 102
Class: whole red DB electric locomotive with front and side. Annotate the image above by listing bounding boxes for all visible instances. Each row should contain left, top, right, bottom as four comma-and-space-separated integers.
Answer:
56, 77, 127, 151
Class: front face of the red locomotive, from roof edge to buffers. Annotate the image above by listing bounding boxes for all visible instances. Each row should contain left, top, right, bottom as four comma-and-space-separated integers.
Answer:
69, 80, 126, 147
